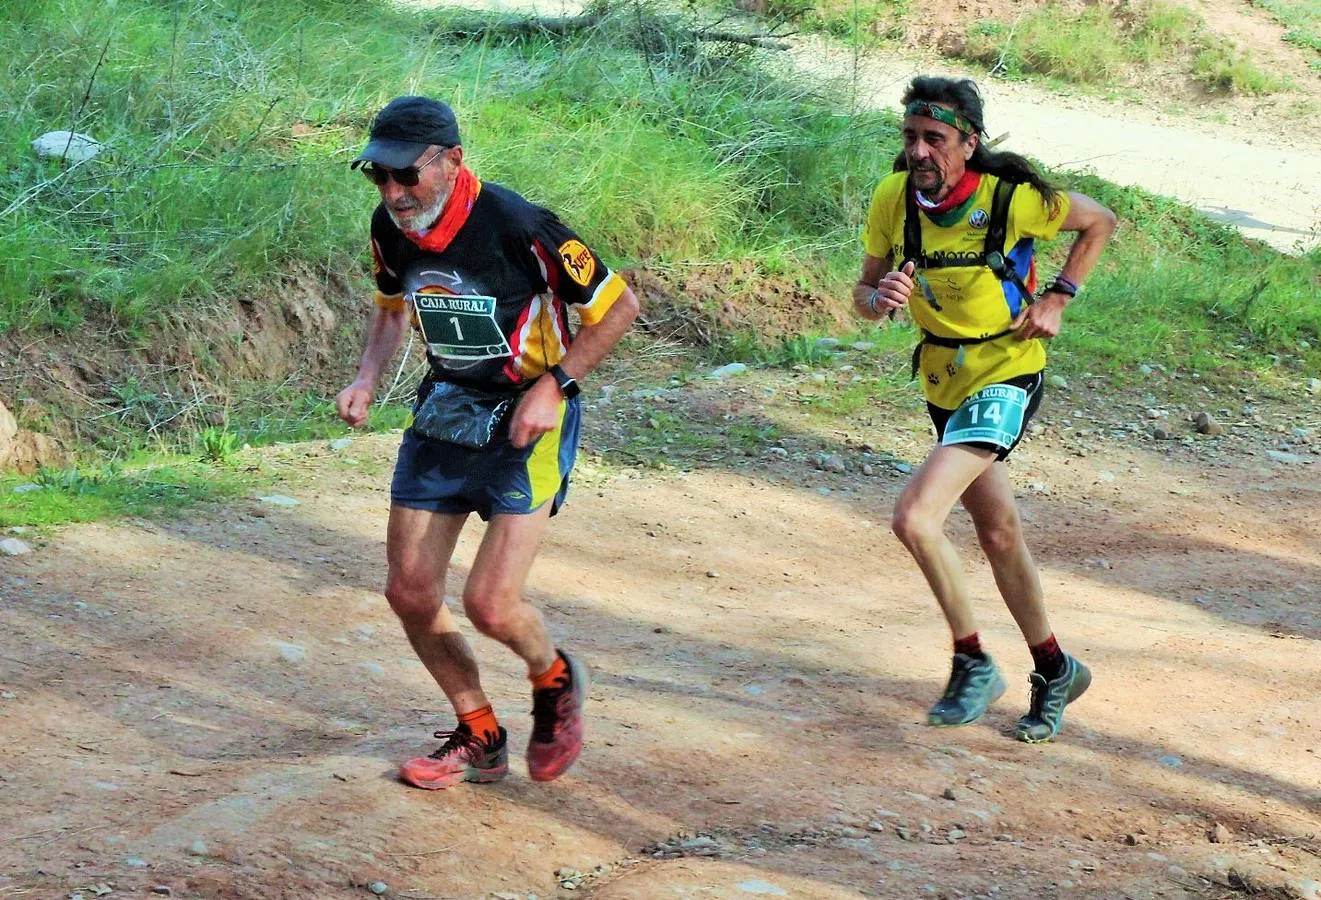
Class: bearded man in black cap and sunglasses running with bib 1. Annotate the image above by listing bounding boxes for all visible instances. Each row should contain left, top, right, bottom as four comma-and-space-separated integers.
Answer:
337, 96, 638, 789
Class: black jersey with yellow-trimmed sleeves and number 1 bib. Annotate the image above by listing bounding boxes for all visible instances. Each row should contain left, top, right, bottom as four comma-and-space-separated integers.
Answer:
371, 182, 624, 391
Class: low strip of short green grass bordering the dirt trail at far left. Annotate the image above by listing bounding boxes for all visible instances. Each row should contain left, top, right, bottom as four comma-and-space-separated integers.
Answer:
0, 457, 250, 526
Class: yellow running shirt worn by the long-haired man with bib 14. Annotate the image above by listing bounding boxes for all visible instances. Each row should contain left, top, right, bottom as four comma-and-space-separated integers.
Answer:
863, 172, 1069, 410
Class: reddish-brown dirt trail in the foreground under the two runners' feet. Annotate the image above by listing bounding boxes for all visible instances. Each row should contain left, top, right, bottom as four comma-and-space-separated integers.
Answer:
0, 362, 1321, 900
